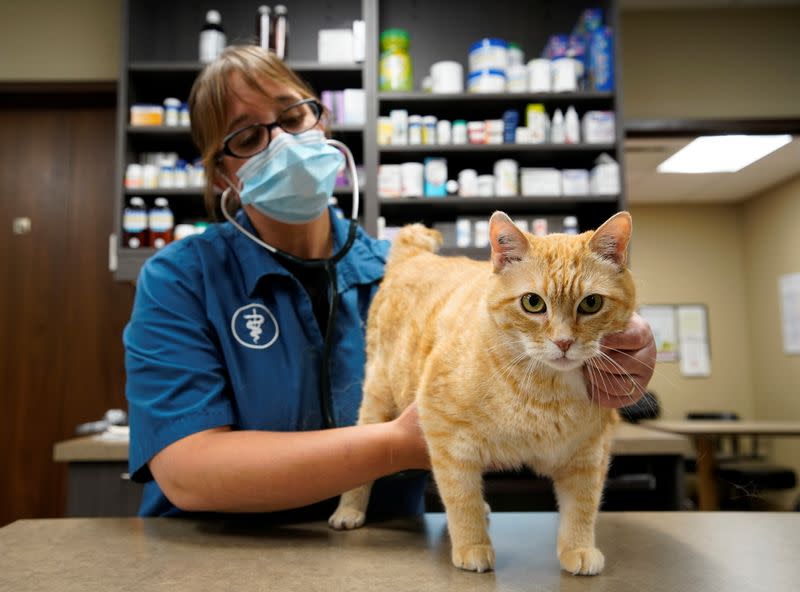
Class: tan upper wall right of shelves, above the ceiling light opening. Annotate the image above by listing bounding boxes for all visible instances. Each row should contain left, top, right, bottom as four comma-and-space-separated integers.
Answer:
622, 7, 800, 119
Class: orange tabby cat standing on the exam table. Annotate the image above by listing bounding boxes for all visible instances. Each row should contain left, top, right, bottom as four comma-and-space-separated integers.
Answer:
329, 212, 635, 574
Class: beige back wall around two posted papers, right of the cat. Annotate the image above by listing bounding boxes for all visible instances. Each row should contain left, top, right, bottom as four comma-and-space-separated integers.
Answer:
630, 205, 753, 419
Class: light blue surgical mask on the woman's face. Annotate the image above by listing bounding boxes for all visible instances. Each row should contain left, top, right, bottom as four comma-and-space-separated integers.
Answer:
237, 129, 345, 224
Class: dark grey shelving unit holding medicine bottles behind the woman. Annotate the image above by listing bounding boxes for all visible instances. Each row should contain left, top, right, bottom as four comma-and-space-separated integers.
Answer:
115, 0, 626, 280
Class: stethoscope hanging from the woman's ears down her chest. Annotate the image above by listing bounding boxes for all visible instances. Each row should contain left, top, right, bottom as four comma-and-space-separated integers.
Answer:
220, 138, 359, 428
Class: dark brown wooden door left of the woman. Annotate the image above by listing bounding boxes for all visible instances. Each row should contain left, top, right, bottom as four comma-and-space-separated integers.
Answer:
0, 88, 133, 526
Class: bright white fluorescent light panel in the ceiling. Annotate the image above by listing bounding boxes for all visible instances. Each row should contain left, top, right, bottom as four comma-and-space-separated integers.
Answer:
658, 134, 792, 173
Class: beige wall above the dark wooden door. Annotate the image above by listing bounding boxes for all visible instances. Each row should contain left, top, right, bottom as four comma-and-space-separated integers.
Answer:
0, 0, 121, 82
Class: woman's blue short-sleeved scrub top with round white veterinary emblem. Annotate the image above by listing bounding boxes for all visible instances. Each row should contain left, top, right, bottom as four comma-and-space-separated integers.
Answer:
123, 210, 425, 518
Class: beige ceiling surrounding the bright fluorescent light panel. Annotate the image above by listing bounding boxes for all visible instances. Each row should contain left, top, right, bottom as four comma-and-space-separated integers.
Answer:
625, 137, 800, 204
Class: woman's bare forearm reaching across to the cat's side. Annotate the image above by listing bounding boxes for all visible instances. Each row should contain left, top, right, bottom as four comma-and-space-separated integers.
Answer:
149, 405, 430, 512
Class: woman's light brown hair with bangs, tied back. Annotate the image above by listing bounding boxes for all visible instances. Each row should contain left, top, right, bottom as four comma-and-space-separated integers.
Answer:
189, 45, 317, 218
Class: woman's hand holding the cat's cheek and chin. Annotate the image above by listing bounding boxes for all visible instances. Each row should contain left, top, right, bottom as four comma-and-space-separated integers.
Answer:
583, 313, 656, 409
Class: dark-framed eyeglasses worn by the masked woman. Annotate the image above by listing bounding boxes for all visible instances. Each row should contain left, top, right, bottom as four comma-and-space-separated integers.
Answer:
222, 99, 322, 158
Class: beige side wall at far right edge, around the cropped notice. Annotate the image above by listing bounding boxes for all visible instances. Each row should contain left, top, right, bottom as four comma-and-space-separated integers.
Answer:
741, 177, 800, 504
